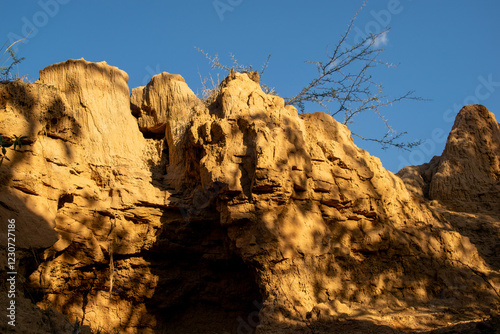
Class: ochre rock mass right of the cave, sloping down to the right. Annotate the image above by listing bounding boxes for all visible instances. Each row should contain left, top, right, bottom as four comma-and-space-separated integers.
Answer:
190, 73, 500, 333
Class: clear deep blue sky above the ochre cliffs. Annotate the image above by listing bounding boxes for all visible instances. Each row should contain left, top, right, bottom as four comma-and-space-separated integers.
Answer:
0, 0, 500, 172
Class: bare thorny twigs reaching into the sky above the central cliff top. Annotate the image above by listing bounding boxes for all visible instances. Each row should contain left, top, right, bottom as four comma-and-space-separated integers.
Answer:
198, 1, 423, 150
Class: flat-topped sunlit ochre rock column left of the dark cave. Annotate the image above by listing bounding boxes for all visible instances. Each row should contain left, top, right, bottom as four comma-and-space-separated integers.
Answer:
0, 60, 169, 332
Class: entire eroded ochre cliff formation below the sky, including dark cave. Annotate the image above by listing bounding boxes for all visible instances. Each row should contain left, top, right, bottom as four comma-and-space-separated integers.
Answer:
0, 60, 500, 333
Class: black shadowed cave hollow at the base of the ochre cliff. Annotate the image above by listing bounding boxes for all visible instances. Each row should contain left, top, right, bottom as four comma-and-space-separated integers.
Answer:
144, 215, 262, 334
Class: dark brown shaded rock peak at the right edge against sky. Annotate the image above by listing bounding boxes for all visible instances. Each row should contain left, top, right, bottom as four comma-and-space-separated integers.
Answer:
399, 105, 500, 211
